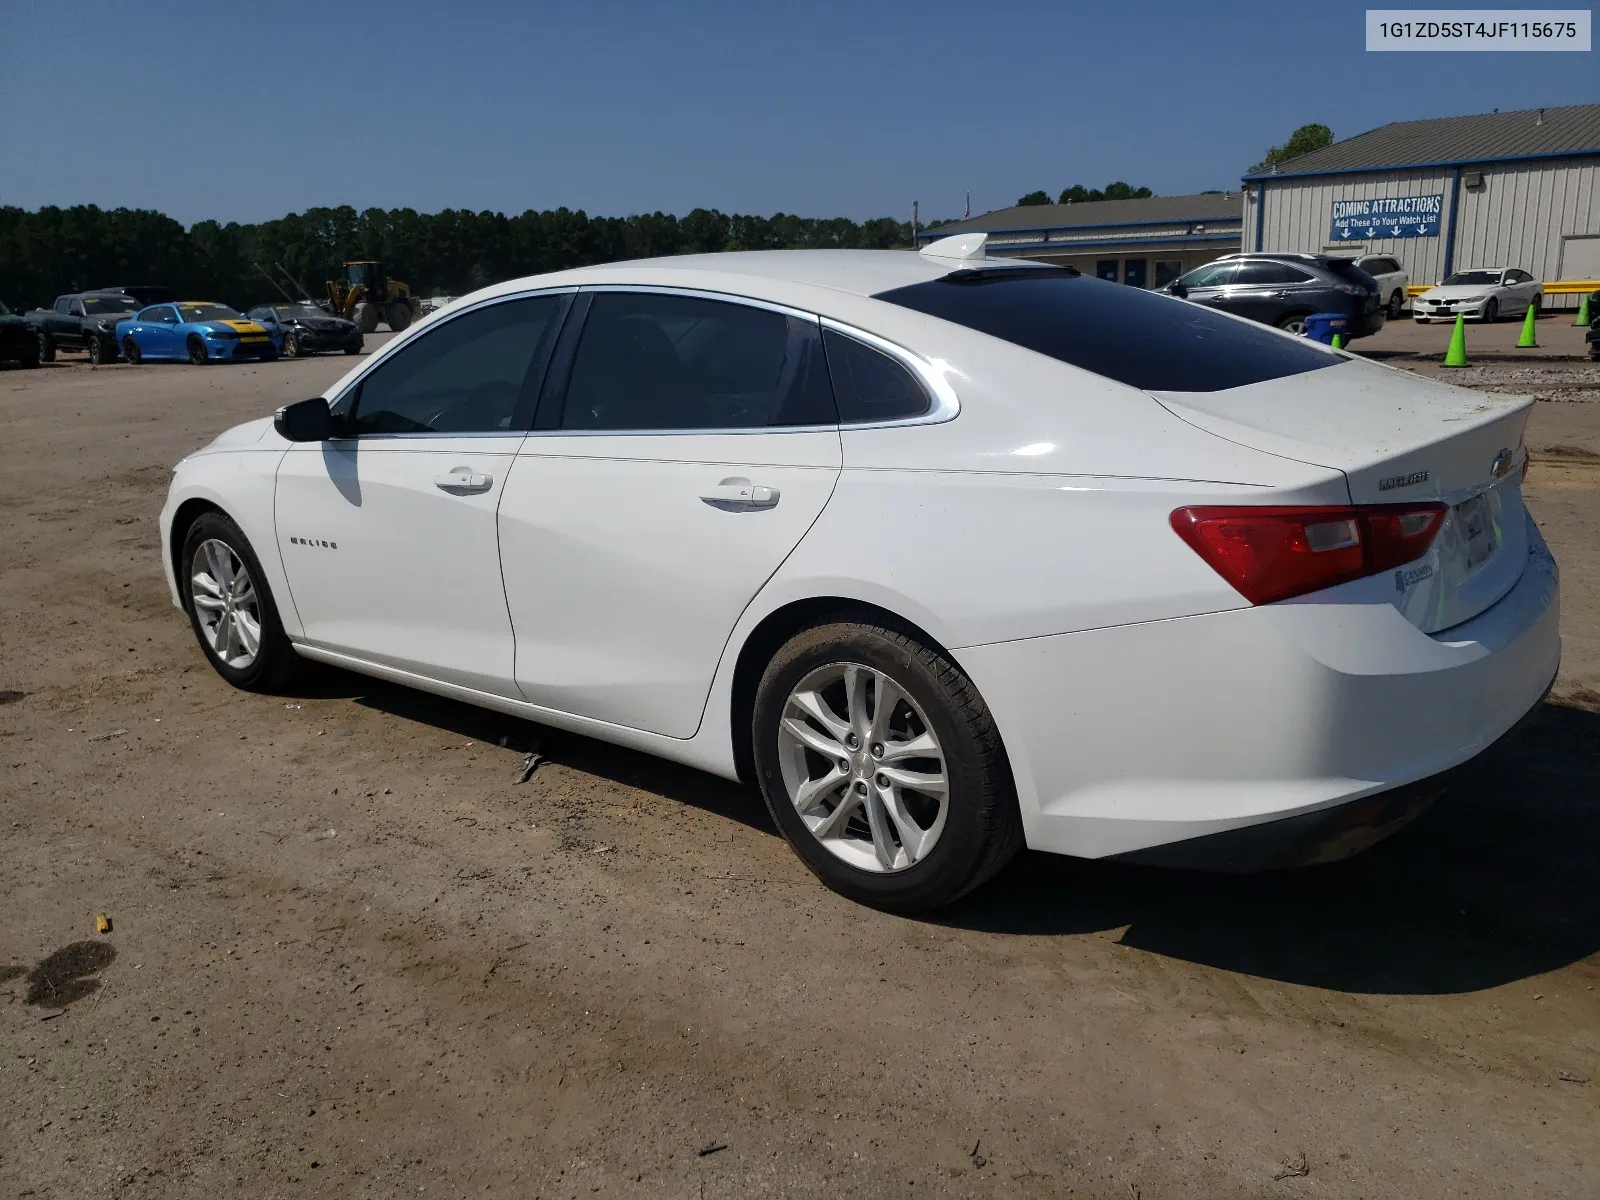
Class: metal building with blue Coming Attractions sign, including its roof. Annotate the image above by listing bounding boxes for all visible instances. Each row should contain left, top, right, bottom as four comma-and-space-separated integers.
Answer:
1243, 104, 1600, 307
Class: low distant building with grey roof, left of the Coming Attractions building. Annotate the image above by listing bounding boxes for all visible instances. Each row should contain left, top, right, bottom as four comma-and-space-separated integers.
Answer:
917, 192, 1243, 288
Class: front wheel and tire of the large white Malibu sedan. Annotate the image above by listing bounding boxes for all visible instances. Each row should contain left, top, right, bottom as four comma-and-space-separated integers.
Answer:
178, 512, 301, 691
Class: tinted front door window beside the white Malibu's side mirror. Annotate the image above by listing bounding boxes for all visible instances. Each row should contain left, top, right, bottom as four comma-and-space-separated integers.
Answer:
336, 296, 566, 435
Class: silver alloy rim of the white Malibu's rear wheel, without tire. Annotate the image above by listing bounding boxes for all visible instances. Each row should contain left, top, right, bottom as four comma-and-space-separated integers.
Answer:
778, 662, 950, 874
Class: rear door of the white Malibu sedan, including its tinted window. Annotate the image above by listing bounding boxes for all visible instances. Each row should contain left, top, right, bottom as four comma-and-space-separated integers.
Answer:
499, 288, 840, 738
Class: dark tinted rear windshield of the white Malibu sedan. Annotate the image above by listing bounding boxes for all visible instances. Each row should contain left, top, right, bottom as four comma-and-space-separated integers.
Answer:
877, 267, 1342, 392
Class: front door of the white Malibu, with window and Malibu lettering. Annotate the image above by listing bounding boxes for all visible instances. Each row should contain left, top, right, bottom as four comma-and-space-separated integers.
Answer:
275, 291, 571, 698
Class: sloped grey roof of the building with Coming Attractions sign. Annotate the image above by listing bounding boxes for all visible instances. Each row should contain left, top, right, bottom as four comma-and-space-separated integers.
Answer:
1245, 104, 1600, 179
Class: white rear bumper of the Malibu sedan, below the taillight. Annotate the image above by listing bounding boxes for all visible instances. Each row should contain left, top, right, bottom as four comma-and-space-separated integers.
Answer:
957, 520, 1560, 866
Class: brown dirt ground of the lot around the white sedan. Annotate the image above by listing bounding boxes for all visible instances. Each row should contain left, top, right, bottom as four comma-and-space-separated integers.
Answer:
0, 336, 1600, 1200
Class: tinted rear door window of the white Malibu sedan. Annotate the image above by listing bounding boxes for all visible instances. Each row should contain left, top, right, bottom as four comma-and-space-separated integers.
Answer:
562, 291, 838, 430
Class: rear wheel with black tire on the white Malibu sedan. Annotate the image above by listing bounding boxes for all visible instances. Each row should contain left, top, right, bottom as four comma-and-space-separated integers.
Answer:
752, 621, 1022, 914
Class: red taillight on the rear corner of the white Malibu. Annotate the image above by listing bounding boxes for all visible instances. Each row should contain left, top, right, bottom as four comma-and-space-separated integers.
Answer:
1171, 504, 1446, 605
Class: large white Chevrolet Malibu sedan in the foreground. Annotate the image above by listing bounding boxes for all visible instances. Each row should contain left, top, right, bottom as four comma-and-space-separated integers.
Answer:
162, 235, 1560, 912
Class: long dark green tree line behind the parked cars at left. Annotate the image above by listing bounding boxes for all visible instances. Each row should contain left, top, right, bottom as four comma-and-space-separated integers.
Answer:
0, 205, 942, 312
